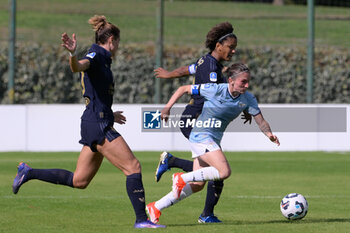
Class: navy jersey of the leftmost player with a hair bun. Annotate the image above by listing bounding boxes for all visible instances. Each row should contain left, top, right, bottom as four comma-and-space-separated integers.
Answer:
80, 44, 114, 122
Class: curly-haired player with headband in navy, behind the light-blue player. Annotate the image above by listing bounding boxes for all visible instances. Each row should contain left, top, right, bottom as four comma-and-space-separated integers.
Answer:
154, 22, 250, 223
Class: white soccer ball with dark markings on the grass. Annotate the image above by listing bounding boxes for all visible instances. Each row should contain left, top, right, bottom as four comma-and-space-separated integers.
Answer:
280, 193, 309, 220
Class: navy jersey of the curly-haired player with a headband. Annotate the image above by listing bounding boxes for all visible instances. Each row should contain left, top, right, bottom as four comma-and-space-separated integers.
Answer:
192, 53, 226, 105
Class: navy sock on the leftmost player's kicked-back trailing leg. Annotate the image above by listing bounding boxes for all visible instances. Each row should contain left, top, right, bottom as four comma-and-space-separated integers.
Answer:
28, 169, 74, 187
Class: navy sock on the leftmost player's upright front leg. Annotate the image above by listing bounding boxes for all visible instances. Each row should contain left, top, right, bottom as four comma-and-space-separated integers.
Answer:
126, 173, 147, 222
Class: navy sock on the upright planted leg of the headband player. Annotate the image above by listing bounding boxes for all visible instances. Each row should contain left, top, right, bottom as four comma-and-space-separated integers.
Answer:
201, 180, 224, 217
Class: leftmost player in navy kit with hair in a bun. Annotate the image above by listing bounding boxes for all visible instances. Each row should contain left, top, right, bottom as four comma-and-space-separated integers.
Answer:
12, 15, 165, 228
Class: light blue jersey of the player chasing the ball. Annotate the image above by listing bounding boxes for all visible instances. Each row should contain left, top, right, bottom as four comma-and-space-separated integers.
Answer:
190, 83, 260, 145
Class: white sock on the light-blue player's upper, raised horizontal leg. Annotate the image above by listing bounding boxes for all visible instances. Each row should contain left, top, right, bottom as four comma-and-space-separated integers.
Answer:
181, 167, 220, 183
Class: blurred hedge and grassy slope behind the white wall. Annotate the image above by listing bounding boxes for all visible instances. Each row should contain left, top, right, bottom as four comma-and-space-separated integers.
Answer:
0, 0, 350, 104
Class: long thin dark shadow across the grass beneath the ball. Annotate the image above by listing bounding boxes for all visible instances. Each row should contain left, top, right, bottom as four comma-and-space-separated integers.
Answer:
167, 218, 350, 227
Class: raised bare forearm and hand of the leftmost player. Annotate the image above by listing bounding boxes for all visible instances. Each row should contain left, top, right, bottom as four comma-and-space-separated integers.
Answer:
61, 33, 90, 72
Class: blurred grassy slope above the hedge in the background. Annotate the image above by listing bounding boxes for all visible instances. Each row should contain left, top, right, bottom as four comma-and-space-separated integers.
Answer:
0, 0, 350, 48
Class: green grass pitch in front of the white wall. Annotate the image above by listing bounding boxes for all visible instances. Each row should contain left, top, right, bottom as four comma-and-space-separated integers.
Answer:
0, 152, 350, 233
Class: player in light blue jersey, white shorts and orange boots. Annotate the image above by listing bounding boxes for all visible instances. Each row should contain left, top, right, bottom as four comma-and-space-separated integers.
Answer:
147, 64, 280, 223
